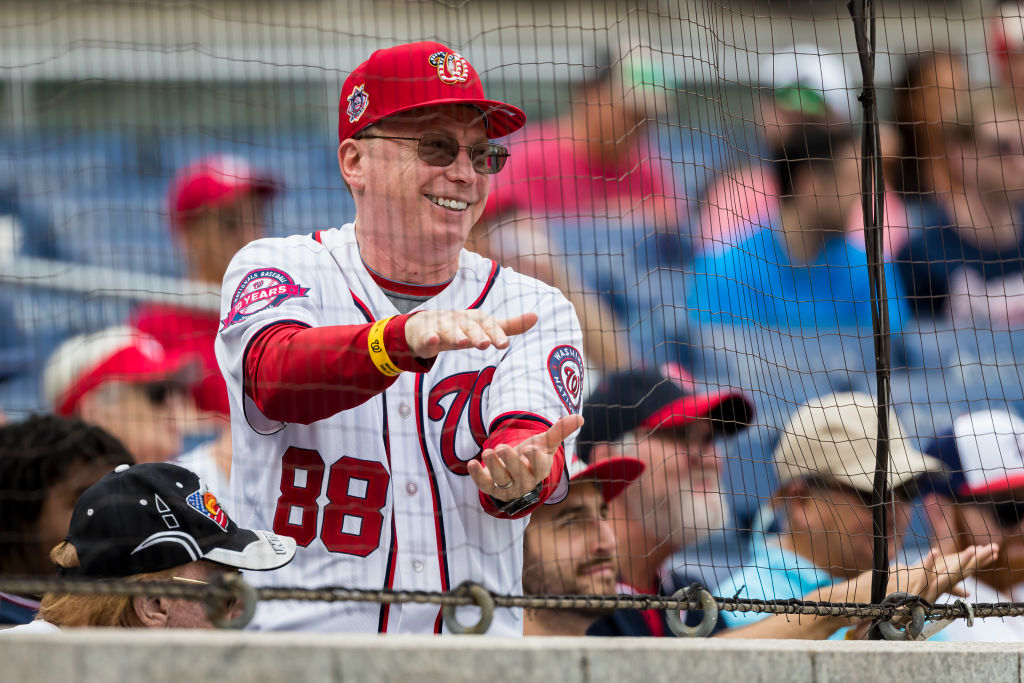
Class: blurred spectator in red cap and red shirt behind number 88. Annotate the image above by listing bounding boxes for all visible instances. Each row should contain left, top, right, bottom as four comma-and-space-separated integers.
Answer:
132, 156, 280, 485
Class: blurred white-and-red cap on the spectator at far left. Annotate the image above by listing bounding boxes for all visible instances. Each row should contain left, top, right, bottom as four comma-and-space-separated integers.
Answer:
43, 326, 190, 416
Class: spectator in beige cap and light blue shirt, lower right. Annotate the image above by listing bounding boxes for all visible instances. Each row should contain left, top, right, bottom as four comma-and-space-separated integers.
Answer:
716, 392, 942, 636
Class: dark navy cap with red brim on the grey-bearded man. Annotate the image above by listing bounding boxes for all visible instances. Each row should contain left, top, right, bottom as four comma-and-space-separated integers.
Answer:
577, 369, 754, 462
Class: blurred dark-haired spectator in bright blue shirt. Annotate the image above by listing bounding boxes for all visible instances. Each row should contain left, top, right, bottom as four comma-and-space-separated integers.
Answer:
687, 126, 907, 332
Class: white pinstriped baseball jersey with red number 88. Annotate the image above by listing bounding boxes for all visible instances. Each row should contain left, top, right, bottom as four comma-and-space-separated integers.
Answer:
216, 224, 584, 635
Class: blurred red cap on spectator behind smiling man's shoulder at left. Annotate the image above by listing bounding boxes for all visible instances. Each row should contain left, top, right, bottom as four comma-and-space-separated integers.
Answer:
168, 155, 278, 227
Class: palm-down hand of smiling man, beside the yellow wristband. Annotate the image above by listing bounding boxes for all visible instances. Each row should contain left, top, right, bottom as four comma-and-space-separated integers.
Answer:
406, 309, 537, 358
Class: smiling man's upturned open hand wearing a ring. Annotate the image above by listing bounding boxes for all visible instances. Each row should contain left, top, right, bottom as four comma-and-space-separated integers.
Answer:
468, 415, 583, 501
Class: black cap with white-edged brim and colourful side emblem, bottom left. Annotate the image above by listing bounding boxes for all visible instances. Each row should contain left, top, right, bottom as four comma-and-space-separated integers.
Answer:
60, 463, 295, 579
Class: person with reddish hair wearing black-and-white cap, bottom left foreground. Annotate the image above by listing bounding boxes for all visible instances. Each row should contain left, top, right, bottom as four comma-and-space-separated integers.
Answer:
11, 463, 295, 633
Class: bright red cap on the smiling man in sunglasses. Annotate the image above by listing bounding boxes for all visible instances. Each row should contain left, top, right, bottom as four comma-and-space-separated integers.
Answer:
338, 41, 526, 142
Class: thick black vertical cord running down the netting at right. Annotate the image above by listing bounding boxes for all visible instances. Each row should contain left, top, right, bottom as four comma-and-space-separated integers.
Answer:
847, 0, 890, 640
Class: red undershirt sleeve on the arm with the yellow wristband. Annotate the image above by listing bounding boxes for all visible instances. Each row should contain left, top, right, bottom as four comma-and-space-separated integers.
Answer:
244, 313, 433, 425
